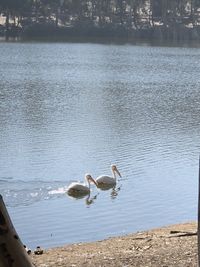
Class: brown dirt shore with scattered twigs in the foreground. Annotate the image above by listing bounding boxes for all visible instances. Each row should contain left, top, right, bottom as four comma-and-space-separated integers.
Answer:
31, 222, 198, 267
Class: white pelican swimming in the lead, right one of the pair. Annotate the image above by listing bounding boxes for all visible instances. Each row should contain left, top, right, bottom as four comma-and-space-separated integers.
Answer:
96, 165, 121, 187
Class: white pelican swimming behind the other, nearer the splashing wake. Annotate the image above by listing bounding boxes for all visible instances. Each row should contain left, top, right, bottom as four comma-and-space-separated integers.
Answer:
67, 174, 97, 196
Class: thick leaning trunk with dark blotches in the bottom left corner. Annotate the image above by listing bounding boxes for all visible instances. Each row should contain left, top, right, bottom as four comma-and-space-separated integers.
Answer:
0, 195, 34, 267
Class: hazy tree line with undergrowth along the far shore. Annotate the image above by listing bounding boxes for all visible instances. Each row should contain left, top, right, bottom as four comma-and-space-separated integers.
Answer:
0, 0, 200, 40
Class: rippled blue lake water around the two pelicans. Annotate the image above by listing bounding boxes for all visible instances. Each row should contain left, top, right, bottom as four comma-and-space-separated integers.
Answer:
0, 43, 200, 249
